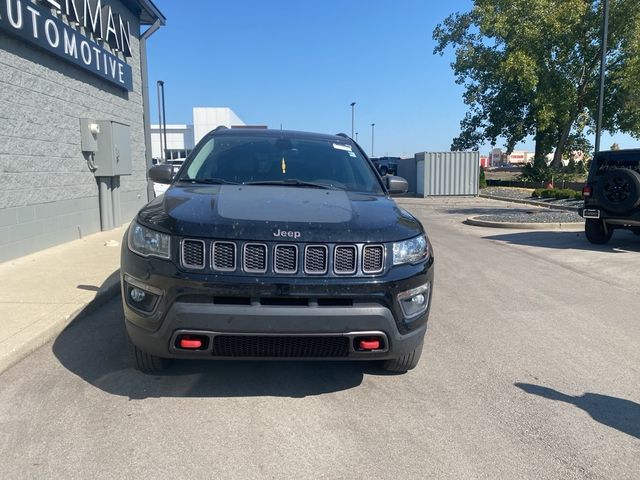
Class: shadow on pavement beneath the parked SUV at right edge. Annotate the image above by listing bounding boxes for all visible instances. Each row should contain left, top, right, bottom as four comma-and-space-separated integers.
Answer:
484, 230, 640, 253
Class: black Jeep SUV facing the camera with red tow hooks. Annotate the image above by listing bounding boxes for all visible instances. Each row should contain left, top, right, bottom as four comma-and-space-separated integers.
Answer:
121, 128, 433, 373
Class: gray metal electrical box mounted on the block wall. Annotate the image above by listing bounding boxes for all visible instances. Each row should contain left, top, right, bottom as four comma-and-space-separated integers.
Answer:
93, 120, 132, 177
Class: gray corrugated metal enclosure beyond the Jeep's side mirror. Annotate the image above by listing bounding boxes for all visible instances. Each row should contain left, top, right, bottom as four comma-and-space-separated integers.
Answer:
416, 152, 480, 197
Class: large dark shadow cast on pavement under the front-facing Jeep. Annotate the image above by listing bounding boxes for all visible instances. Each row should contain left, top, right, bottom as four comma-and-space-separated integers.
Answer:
53, 298, 378, 399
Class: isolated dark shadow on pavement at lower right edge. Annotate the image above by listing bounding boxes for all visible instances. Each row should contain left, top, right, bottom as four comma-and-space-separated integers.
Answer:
514, 383, 640, 438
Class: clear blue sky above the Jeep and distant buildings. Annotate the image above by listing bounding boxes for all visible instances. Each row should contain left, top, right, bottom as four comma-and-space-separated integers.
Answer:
148, 0, 640, 157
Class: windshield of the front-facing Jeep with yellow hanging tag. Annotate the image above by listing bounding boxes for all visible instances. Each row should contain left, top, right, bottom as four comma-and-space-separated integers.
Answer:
177, 135, 383, 193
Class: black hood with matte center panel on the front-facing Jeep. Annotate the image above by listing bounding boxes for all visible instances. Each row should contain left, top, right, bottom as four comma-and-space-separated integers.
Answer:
138, 185, 423, 242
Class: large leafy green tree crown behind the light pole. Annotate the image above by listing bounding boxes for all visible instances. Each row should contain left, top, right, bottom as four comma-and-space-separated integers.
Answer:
433, 0, 640, 168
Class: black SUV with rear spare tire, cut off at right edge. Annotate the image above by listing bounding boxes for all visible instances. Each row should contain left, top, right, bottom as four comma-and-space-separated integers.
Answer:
580, 150, 640, 244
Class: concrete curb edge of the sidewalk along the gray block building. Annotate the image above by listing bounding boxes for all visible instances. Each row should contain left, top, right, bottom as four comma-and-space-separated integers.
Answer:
0, 270, 120, 374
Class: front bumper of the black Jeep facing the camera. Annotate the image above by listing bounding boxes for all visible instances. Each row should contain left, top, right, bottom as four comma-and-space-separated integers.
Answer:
121, 246, 433, 360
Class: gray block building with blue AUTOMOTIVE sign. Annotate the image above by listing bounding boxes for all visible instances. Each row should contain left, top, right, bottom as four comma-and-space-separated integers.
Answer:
0, 0, 165, 261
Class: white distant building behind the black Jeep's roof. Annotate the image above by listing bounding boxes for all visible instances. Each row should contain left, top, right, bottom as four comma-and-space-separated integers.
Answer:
151, 107, 251, 159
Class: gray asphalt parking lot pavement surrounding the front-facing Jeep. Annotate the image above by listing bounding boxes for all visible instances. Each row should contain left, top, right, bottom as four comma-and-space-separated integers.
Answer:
0, 199, 640, 479
